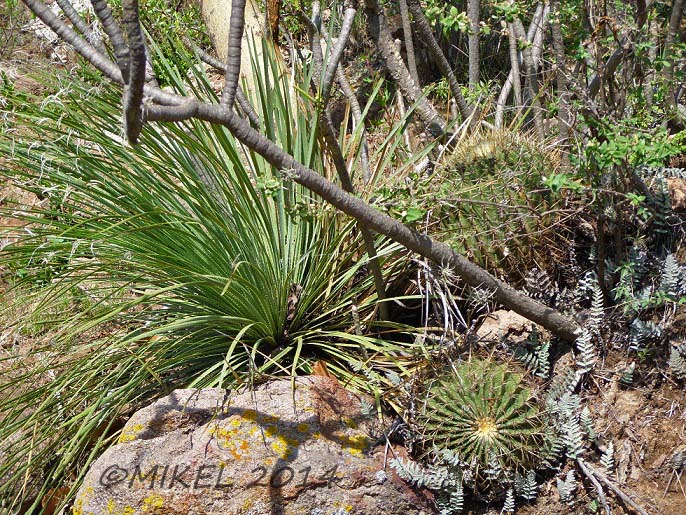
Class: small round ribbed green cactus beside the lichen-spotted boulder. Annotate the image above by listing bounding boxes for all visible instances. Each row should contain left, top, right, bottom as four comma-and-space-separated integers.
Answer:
417, 358, 544, 478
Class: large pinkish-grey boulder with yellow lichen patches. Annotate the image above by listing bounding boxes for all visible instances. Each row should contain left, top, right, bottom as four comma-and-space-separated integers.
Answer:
74, 376, 433, 515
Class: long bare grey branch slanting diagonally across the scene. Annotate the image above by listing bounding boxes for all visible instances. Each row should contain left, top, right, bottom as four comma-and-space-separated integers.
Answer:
18, 0, 578, 341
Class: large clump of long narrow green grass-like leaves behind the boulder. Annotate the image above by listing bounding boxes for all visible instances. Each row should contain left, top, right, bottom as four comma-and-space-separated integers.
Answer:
0, 39, 424, 508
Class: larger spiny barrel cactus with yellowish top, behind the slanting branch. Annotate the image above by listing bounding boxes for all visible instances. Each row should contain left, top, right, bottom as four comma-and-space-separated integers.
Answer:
378, 131, 567, 281
